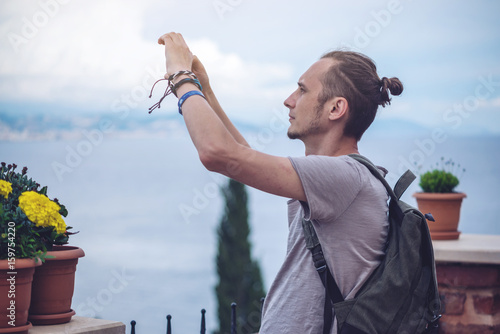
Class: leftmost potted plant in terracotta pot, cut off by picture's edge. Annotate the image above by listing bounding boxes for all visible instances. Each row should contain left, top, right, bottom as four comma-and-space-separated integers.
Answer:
0, 163, 48, 333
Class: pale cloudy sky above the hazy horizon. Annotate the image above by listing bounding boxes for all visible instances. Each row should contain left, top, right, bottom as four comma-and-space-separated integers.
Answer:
0, 0, 500, 140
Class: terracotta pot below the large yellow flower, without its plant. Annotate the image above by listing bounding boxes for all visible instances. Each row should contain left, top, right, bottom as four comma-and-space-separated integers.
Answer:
29, 246, 85, 325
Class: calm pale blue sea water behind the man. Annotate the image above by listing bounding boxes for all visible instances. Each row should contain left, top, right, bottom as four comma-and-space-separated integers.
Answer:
0, 133, 500, 334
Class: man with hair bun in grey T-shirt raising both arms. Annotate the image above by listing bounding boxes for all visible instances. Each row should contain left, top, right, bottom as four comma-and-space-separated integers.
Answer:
159, 33, 403, 334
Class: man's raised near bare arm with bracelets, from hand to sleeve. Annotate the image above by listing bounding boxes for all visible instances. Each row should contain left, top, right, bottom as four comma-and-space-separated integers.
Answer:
158, 33, 306, 201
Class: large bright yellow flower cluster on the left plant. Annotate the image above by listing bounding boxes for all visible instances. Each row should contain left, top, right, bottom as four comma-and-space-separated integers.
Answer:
19, 191, 66, 233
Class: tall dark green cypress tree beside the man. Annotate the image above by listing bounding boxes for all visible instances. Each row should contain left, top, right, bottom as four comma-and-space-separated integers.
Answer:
215, 179, 265, 334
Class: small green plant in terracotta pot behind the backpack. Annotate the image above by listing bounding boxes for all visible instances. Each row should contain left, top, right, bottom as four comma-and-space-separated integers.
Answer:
413, 158, 466, 240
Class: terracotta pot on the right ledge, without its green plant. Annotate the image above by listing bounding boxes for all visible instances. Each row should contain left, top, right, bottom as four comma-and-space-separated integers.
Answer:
413, 193, 467, 240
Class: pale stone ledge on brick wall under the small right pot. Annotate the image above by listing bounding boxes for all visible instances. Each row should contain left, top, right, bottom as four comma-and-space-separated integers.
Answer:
432, 234, 500, 264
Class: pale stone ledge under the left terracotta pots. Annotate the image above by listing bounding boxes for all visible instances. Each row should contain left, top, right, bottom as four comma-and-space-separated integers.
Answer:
29, 316, 125, 334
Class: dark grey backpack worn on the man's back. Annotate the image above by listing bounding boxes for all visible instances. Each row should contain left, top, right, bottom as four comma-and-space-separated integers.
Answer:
302, 154, 441, 334
